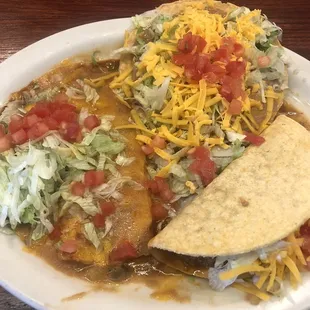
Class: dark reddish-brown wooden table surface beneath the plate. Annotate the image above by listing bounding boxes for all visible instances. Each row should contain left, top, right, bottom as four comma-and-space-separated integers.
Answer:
0, 0, 310, 310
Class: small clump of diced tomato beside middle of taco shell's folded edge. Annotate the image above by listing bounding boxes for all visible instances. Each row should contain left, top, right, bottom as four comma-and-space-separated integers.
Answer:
189, 146, 216, 185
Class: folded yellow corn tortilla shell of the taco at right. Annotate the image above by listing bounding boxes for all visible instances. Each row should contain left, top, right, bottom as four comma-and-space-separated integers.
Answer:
149, 115, 310, 257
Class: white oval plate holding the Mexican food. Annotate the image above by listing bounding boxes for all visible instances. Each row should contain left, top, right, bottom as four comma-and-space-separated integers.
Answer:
0, 18, 310, 310
